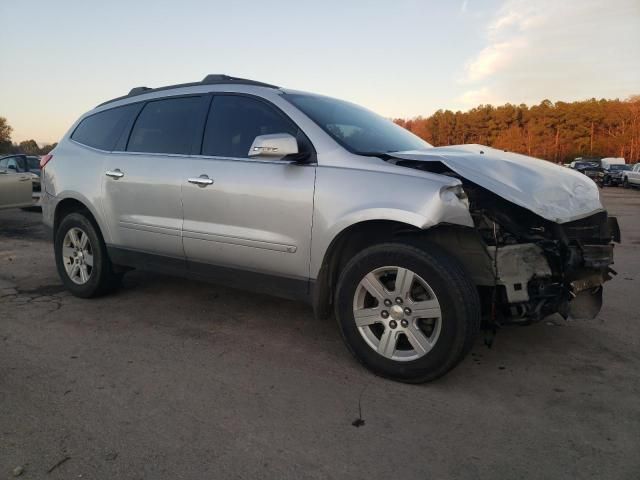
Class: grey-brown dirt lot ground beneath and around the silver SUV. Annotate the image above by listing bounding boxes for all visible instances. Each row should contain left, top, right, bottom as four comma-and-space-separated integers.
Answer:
0, 188, 640, 479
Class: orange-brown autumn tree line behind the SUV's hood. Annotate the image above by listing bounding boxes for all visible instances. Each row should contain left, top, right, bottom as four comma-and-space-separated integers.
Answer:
394, 95, 640, 163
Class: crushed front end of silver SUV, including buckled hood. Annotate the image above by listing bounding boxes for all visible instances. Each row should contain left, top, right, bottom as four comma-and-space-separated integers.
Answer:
388, 145, 620, 325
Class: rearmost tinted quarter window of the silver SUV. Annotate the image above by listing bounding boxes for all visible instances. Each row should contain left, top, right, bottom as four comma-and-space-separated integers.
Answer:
71, 105, 139, 150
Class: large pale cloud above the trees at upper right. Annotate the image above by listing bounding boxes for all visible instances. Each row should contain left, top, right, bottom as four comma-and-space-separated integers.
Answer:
458, 0, 640, 106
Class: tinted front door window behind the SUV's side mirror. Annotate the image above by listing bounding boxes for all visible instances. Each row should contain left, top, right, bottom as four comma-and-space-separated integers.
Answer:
202, 95, 298, 158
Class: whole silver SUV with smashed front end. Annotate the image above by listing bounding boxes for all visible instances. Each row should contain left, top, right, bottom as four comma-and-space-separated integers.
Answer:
42, 75, 619, 382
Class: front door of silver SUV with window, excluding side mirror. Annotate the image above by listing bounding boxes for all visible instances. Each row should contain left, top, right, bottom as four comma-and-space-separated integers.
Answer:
182, 94, 315, 293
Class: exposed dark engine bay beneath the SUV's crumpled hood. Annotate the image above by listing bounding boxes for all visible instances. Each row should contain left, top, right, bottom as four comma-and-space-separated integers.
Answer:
389, 159, 620, 325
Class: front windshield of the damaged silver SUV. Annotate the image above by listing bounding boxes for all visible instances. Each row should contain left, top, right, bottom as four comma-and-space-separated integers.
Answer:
283, 94, 431, 155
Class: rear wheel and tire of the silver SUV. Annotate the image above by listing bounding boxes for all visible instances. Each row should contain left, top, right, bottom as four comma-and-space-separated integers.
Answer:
54, 212, 122, 298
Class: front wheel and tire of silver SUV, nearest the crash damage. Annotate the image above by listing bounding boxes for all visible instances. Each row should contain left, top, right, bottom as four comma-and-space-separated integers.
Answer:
335, 243, 481, 383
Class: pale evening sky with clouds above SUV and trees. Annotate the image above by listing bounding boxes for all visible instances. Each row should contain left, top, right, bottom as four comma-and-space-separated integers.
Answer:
0, 0, 640, 144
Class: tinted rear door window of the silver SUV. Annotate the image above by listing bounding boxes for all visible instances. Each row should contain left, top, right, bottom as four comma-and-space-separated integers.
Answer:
127, 97, 202, 155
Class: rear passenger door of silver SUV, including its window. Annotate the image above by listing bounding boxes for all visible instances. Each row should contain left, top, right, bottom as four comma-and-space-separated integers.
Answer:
103, 95, 208, 269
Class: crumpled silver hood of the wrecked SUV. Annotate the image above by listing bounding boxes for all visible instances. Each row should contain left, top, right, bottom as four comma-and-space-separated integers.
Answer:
392, 144, 604, 223
